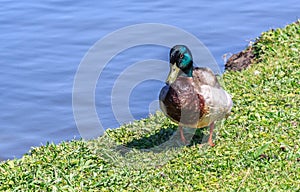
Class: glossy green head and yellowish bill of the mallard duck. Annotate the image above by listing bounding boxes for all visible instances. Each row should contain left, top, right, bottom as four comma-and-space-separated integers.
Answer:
166, 45, 193, 84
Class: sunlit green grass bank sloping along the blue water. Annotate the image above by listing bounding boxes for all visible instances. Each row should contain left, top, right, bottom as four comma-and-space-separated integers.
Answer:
0, 21, 300, 191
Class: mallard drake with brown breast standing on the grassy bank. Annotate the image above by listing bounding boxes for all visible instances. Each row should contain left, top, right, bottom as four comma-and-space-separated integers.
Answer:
159, 45, 232, 146
